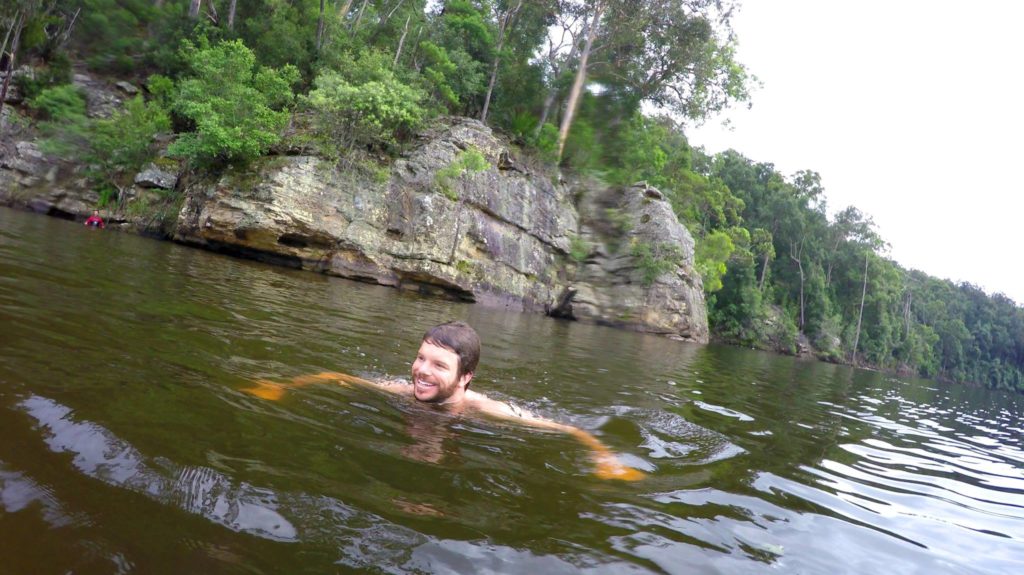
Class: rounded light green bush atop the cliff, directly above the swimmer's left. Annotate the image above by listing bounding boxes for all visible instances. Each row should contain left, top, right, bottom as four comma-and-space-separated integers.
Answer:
303, 60, 426, 147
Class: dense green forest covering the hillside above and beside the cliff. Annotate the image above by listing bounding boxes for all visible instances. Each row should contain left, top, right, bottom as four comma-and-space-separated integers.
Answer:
0, 0, 1024, 391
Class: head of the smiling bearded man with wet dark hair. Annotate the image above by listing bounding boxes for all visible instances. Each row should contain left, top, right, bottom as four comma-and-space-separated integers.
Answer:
413, 321, 480, 403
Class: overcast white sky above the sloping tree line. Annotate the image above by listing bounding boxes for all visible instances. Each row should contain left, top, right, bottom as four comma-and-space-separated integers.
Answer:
687, 0, 1024, 305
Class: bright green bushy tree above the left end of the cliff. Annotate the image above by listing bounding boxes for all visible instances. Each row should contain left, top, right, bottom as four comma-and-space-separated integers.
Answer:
168, 41, 299, 165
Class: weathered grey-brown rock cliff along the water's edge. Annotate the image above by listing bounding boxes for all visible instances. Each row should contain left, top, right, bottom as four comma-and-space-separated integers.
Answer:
0, 96, 708, 343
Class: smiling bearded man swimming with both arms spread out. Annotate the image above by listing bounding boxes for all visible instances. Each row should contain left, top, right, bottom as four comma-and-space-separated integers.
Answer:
244, 321, 644, 481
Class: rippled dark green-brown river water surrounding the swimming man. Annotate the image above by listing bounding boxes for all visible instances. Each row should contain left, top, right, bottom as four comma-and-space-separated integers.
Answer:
0, 209, 1024, 574
